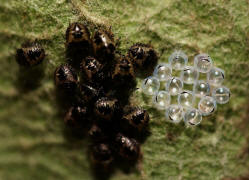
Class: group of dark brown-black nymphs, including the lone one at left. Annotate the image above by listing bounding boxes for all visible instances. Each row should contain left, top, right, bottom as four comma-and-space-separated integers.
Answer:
17, 22, 158, 173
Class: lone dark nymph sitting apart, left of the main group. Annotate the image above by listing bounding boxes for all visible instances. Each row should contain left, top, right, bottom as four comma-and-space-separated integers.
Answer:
16, 42, 46, 66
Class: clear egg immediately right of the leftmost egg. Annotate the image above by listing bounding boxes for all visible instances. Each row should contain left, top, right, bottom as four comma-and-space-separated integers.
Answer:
165, 77, 183, 96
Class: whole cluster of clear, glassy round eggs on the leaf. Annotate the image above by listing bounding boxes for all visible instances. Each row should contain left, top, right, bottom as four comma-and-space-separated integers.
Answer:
141, 51, 230, 126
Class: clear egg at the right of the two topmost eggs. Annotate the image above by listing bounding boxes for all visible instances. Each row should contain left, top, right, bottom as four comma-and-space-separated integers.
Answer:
194, 54, 213, 73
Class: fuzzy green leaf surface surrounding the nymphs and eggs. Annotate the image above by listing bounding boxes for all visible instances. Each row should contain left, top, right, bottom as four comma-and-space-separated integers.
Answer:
0, 0, 249, 180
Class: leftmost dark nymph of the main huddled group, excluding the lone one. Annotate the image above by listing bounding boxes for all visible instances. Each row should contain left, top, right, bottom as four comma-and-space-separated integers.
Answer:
54, 64, 78, 93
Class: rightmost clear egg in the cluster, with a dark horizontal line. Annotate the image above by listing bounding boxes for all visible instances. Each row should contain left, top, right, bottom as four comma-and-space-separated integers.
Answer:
212, 86, 230, 104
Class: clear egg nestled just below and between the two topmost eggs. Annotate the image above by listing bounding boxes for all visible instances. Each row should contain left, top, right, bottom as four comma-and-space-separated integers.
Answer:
181, 66, 199, 84
